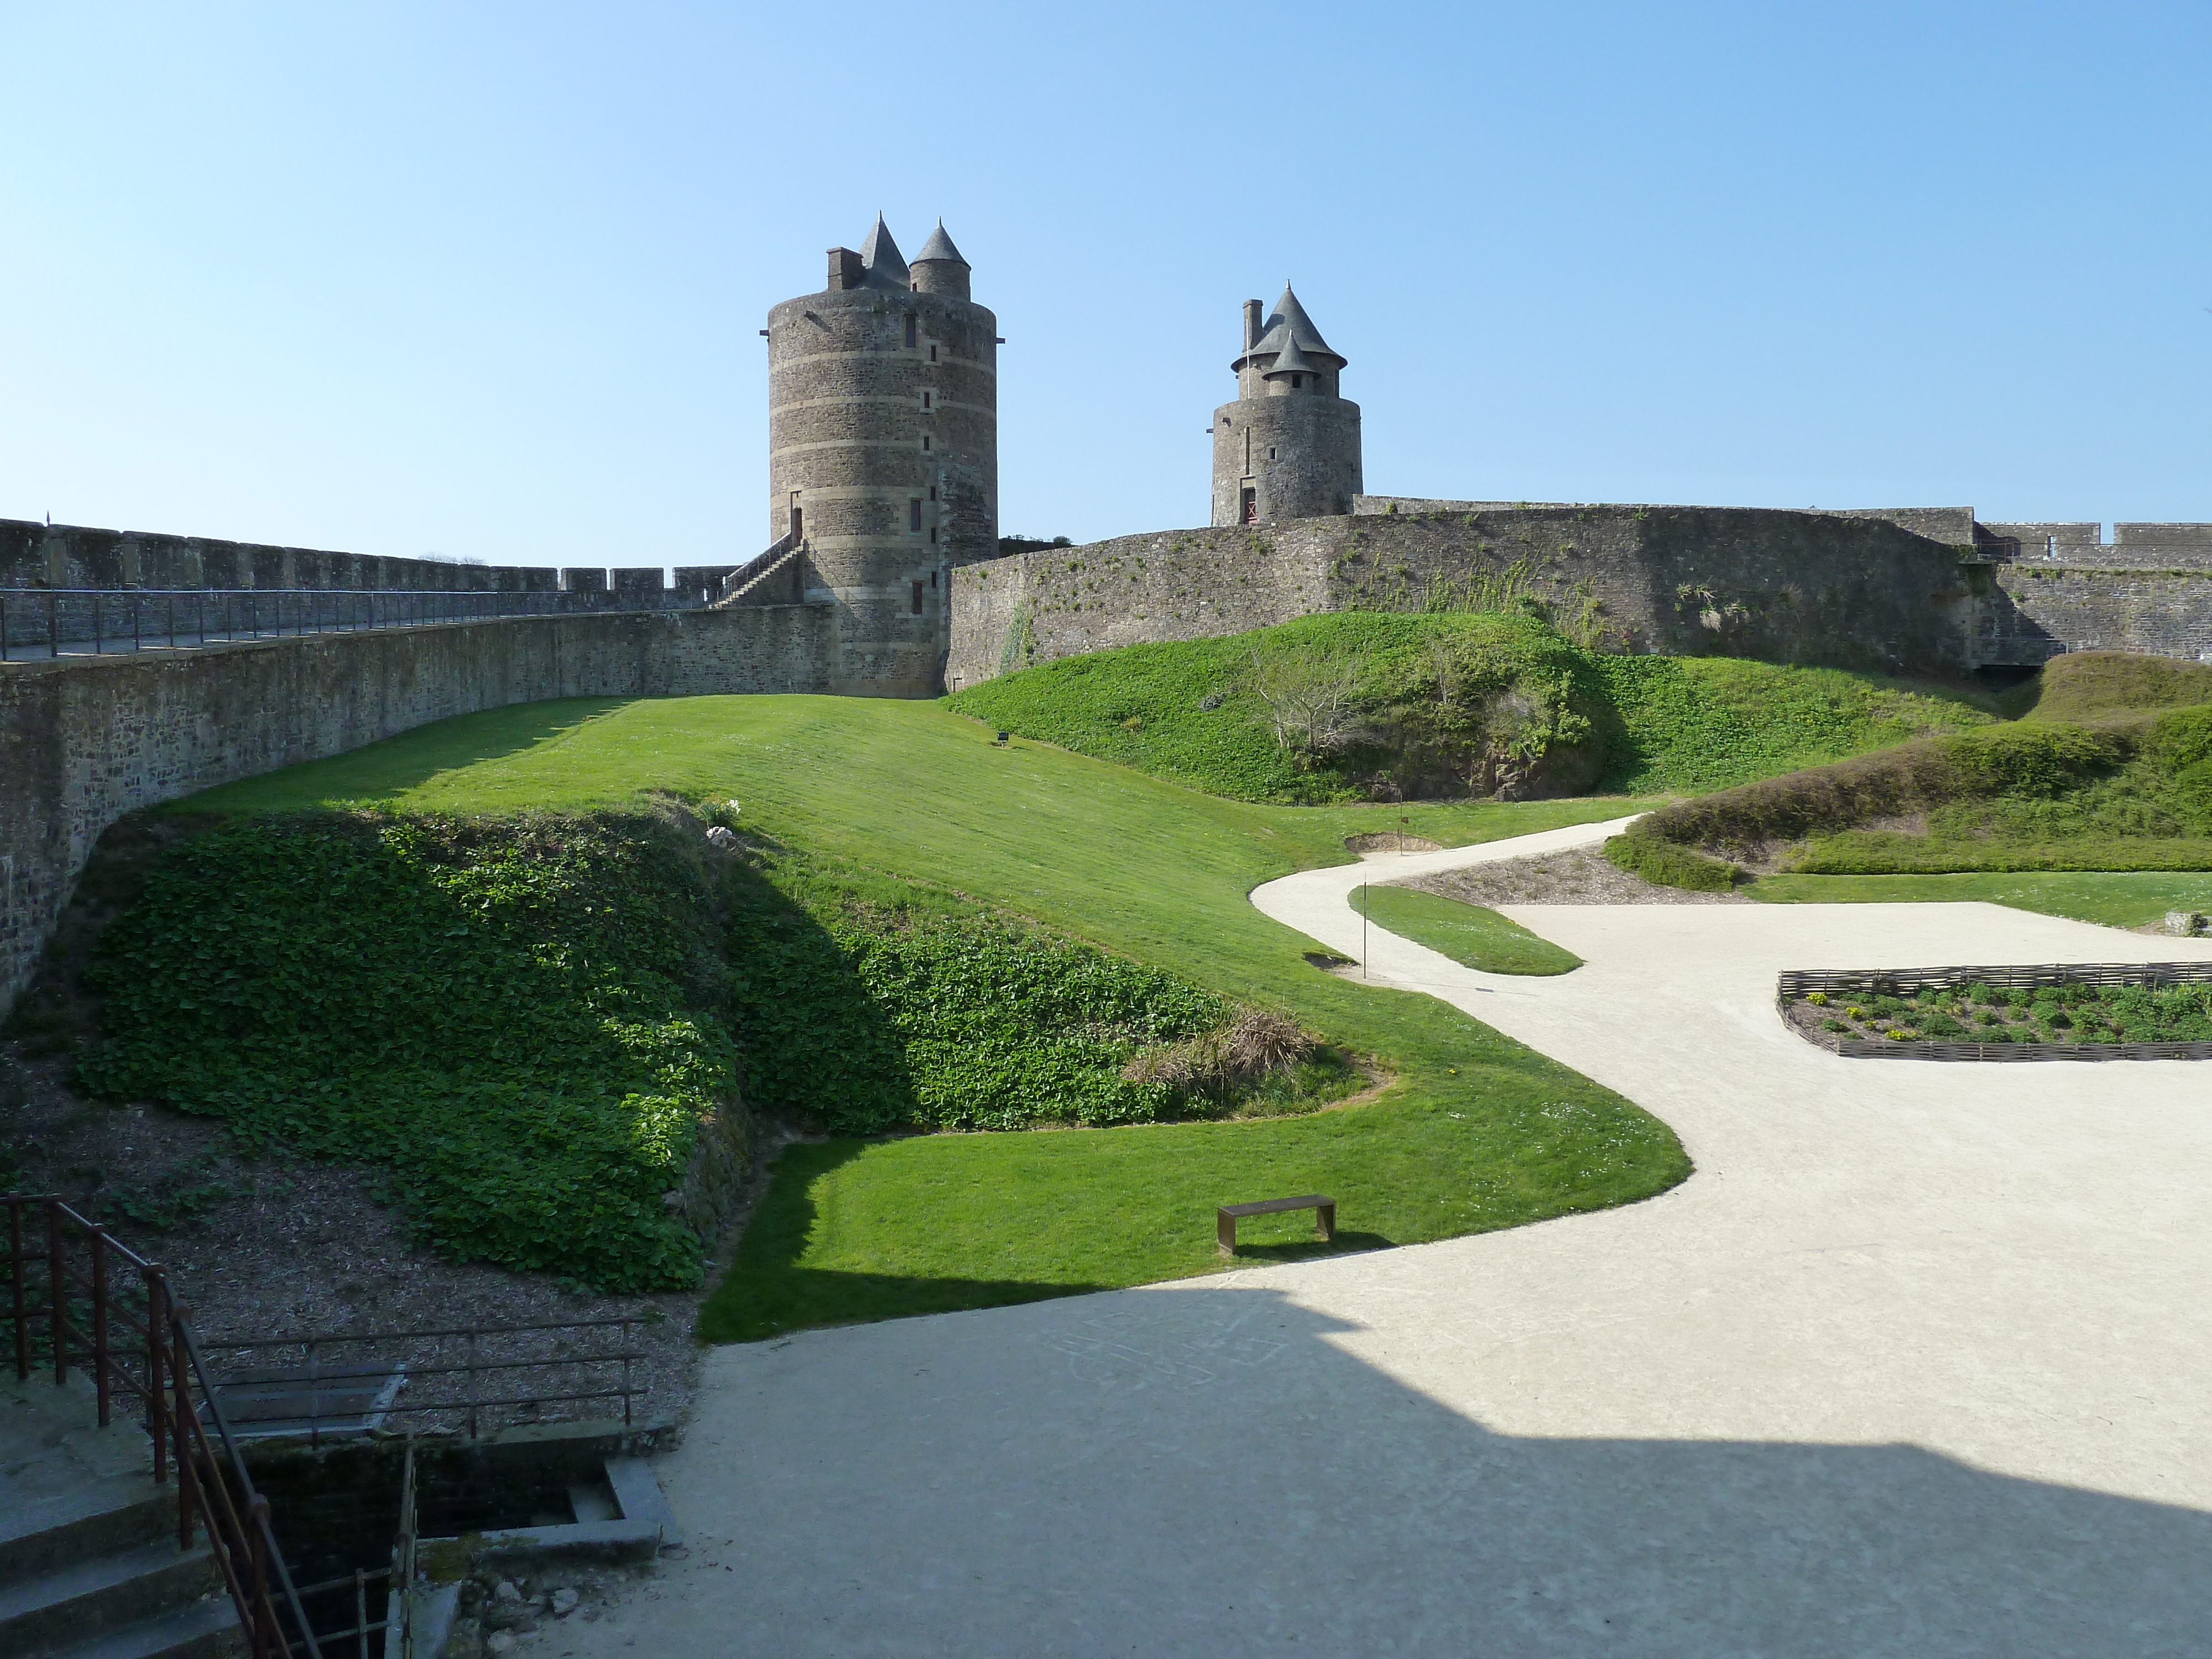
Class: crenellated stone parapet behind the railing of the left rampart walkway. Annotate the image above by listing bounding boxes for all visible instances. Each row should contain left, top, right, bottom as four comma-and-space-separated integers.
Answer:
0, 518, 750, 611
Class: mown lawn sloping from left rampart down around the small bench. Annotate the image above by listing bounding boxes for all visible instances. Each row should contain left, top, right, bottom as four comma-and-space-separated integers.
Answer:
177, 697, 1688, 1340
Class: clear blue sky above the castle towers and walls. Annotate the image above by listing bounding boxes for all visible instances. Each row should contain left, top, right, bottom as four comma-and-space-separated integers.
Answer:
0, 0, 2212, 564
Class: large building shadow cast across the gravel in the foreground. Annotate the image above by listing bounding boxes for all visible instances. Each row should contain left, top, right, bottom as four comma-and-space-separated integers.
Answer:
668, 1285, 2212, 1659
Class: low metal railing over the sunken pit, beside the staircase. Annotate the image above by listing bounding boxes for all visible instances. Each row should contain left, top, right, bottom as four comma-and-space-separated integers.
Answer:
191, 1314, 648, 1444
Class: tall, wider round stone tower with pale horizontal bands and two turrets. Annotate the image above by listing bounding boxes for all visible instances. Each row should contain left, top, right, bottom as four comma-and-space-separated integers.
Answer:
768, 215, 998, 697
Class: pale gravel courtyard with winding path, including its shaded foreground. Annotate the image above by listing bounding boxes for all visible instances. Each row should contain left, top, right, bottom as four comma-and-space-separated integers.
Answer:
549, 825, 2212, 1659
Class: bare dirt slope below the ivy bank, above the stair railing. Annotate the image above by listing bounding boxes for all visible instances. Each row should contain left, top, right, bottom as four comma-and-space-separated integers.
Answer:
0, 1044, 721, 1422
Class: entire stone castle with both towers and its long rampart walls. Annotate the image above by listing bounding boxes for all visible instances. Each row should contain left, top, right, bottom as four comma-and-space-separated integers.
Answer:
0, 217, 2212, 1006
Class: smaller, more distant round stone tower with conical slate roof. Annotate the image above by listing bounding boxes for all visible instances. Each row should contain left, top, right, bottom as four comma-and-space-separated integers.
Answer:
1214, 283, 1360, 524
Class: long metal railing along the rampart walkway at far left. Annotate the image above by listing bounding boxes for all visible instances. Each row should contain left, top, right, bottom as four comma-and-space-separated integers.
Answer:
0, 588, 699, 661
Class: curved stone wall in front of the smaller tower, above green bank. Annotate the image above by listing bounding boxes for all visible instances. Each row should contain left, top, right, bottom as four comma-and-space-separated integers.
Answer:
947, 498, 1973, 690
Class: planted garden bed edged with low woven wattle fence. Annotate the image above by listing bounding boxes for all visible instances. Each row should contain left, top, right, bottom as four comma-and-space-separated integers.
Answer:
1774, 962, 2212, 1060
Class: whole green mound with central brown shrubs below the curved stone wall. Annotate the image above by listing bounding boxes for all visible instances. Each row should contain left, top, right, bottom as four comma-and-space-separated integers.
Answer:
949, 611, 1993, 801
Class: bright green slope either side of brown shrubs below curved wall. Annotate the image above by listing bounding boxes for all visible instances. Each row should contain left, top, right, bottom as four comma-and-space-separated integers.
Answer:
949, 611, 1991, 801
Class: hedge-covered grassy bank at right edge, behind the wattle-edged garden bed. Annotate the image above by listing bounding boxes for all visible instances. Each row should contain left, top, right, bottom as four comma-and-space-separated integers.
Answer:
1608, 653, 2212, 885
